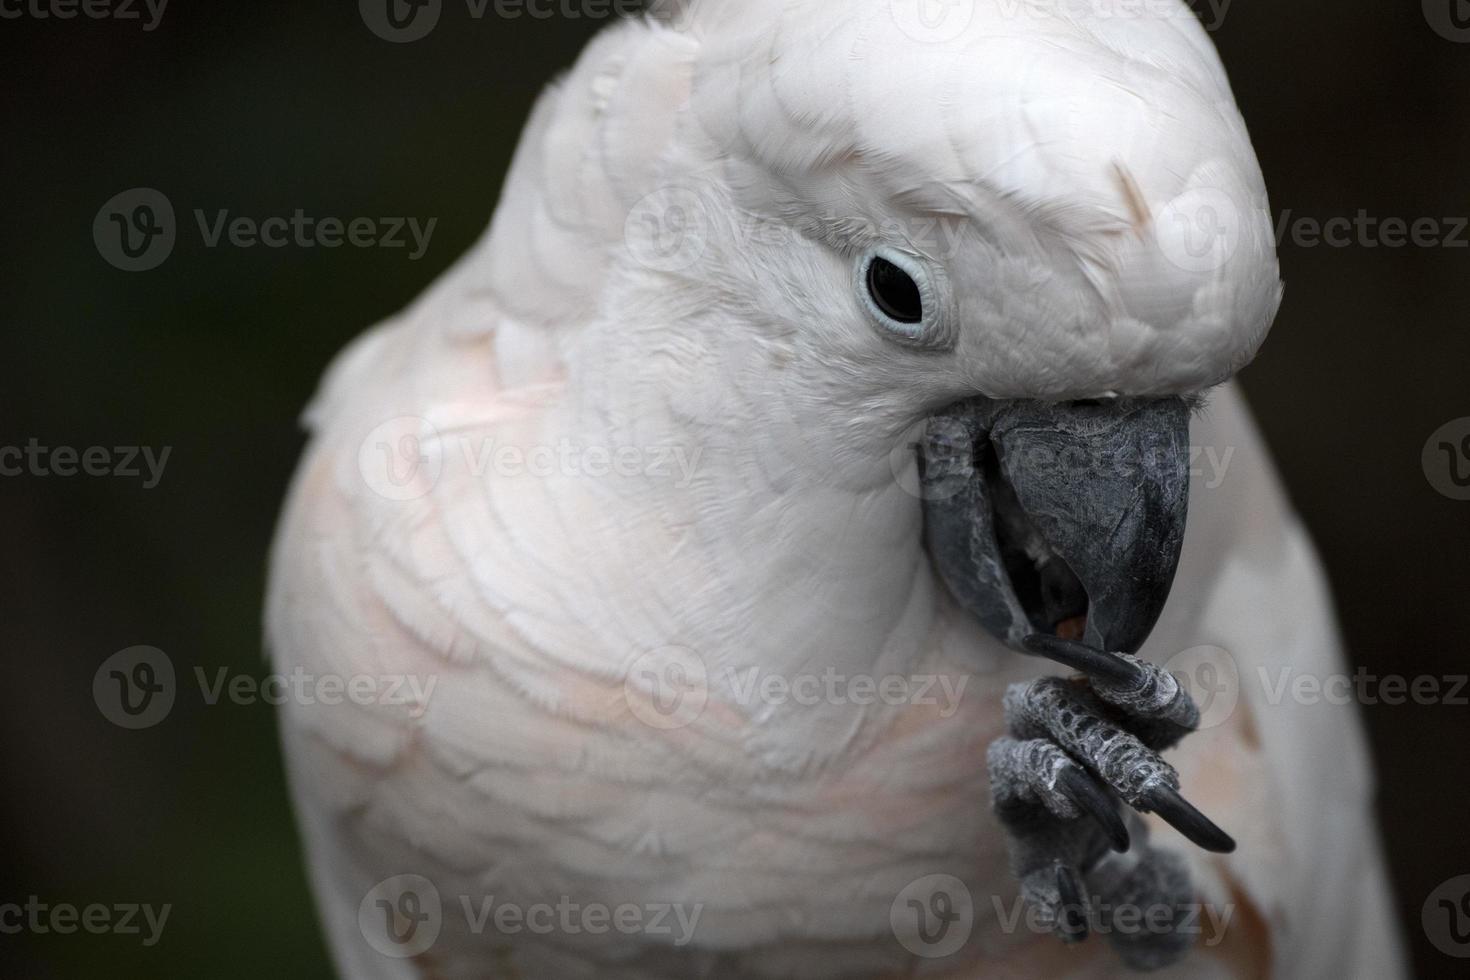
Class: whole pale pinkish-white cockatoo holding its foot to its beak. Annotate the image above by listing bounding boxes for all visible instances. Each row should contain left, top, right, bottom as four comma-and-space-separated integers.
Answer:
268, 0, 1399, 980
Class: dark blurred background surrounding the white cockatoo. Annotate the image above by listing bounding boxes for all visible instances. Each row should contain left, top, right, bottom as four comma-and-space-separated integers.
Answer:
0, 0, 1470, 980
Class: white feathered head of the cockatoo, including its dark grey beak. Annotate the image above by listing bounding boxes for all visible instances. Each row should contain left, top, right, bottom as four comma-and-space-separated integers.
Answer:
620, 0, 1280, 652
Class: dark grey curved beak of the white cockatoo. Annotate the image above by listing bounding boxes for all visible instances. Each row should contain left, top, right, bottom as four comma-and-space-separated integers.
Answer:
919, 398, 1189, 654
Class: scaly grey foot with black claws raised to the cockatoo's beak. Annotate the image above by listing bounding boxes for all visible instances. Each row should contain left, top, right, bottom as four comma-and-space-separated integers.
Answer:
988, 635, 1235, 970
